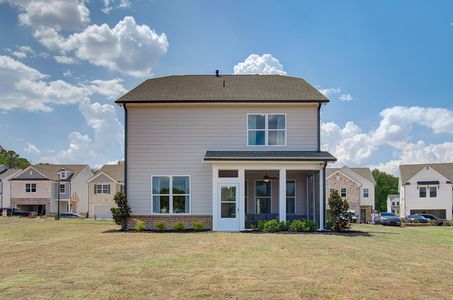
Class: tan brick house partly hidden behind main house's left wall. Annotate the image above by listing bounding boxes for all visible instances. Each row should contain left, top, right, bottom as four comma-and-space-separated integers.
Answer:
88, 165, 124, 219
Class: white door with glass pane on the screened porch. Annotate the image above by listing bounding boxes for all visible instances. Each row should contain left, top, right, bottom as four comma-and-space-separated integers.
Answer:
217, 183, 240, 231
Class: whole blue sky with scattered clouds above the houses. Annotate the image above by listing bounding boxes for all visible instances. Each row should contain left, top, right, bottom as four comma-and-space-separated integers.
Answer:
0, 0, 453, 173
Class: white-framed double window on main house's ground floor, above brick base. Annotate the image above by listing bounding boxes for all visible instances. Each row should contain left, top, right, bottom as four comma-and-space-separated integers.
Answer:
152, 176, 190, 214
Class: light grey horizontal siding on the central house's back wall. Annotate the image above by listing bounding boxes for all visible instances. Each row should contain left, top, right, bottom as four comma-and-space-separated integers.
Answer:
127, 105, 318, 215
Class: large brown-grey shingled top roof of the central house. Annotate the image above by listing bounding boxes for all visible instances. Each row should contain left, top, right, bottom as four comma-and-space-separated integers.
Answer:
116, 75, 329, 103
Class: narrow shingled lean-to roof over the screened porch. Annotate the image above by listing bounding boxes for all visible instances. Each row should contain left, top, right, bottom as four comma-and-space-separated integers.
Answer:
204, 151, 337, 161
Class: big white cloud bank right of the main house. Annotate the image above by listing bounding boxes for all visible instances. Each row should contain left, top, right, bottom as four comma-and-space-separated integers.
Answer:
321, 106, 453, 174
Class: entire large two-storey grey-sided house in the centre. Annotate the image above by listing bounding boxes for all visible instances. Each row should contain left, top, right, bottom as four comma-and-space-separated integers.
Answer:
116, 74, 336, 231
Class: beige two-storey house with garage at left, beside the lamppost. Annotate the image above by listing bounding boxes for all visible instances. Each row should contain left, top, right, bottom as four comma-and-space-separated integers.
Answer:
10, 164, 93, 215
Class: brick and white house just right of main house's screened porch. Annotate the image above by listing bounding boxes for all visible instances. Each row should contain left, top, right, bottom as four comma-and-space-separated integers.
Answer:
326, 166, 376, 223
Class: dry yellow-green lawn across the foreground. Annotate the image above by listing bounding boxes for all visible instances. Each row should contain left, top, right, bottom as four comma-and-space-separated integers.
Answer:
0, 218, 453, 299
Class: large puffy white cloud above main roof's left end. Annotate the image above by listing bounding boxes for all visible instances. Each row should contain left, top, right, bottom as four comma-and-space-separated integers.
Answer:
34, 17, 168, 77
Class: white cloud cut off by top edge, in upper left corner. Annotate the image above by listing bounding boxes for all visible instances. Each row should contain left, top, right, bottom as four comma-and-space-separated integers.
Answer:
6, 0, 90, 31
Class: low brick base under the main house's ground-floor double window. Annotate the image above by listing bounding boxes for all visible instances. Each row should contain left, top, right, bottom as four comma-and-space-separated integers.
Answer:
127, 215, 212, 230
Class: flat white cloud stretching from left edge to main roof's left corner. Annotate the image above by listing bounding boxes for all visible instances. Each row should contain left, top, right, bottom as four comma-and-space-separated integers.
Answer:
0, 56, 125, 111
